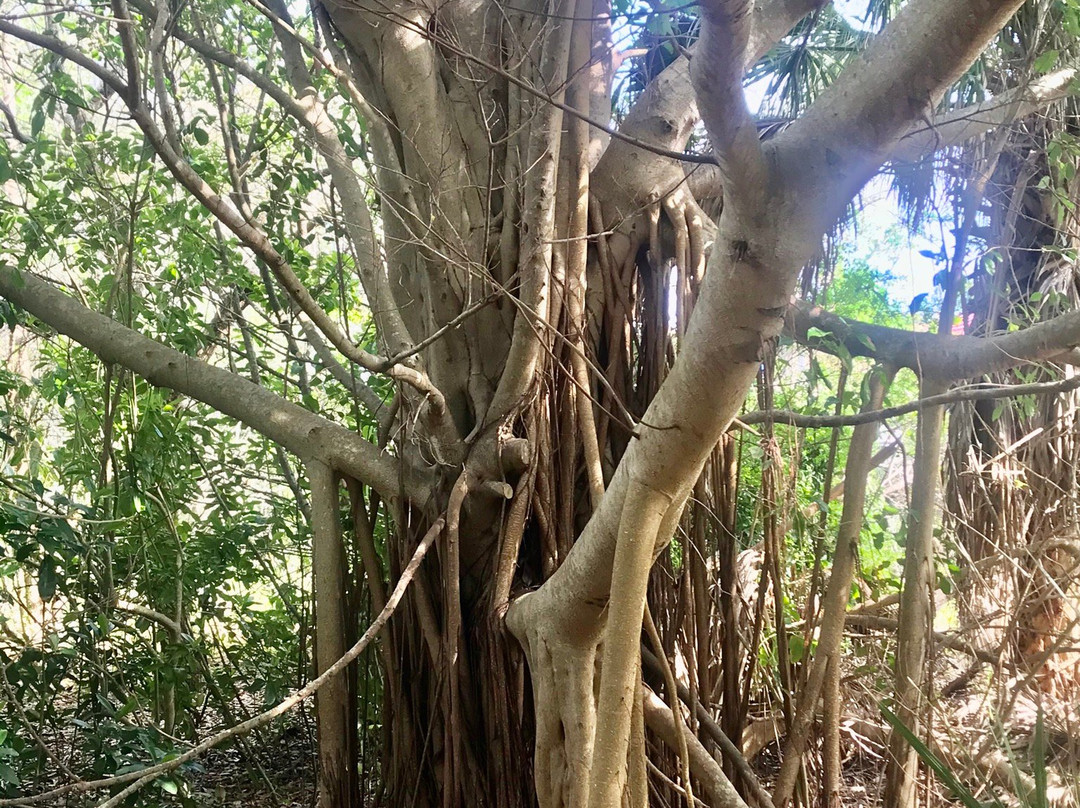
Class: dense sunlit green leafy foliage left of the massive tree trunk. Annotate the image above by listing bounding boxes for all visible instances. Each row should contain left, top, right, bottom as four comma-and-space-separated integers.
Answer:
0, 3, 393, 806
